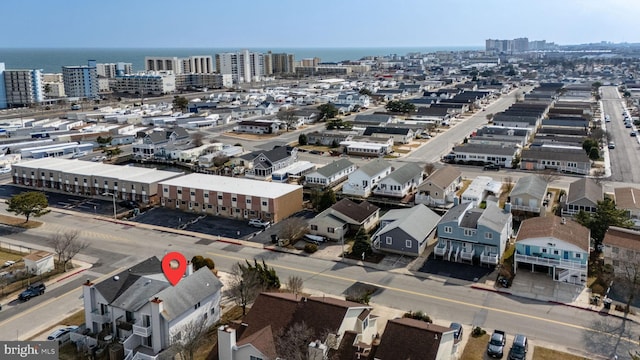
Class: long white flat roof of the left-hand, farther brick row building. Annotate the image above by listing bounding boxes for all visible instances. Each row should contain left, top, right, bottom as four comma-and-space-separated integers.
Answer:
14, 158, 183, 183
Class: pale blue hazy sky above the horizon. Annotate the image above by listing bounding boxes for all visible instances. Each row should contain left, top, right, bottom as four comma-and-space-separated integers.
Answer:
0, 0, 640, 48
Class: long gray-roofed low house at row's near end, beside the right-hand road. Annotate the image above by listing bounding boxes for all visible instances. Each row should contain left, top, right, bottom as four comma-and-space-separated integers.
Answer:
520, 146, 591, 175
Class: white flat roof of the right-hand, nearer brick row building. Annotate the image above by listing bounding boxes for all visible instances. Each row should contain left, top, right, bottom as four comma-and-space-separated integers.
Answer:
159, 174, 302, 199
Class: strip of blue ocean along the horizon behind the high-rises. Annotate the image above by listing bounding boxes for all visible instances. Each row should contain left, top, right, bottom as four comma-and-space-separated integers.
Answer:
0, 46, 483, 73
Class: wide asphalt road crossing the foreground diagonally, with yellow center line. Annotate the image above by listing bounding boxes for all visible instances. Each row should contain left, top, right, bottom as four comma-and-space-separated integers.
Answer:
2, 211, 640, 356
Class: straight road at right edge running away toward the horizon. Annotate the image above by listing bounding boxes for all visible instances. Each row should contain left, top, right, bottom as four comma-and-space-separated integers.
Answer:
601, 86, 640, 184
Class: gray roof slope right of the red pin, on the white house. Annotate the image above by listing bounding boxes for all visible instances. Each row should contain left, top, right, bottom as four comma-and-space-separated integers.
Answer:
154, 267, 222, 320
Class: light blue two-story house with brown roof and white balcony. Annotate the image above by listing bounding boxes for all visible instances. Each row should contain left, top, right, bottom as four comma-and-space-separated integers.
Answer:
514, 216, 591, 286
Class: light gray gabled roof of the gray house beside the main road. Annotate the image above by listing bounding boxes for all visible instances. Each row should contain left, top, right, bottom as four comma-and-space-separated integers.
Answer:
380, 204, 440, 240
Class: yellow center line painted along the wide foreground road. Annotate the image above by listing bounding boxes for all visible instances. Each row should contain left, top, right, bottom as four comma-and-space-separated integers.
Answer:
207, 252, 631, 341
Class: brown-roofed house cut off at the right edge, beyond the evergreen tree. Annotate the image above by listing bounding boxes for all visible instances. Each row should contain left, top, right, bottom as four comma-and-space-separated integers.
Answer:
602, 226, 640, 277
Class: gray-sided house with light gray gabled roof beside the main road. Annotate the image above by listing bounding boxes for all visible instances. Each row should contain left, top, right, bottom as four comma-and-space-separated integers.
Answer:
371, 204, 440, 256
